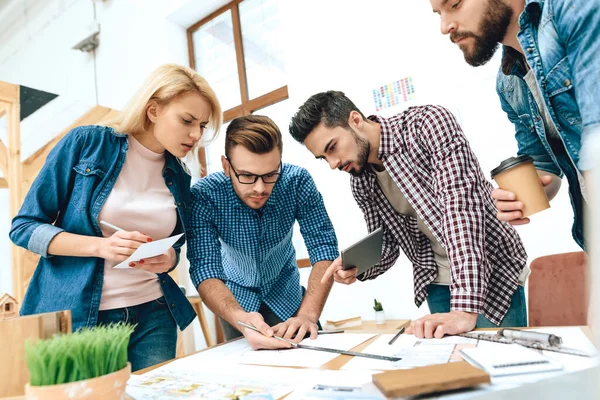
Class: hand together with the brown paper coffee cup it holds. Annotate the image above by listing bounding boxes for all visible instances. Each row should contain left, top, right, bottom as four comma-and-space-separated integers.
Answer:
492, 156, 552, 225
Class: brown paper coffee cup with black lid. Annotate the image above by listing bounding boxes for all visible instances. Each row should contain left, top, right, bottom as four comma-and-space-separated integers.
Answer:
492, 156, 550, 218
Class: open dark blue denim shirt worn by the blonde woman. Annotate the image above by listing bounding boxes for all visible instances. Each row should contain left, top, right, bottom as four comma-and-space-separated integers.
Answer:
10, 126, 196, 330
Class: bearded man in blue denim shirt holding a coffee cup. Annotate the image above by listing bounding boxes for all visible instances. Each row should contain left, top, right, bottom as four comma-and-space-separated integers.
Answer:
430, 0, 600, 247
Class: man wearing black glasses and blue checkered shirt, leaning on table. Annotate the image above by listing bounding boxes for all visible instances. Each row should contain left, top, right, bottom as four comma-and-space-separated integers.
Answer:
186, 115, 338, 349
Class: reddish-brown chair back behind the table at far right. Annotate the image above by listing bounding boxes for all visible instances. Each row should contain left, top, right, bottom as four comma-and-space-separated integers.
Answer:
528, 251, 589, 326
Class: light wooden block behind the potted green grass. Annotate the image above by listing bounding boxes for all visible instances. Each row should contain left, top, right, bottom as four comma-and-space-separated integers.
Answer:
0, 311, 72, 397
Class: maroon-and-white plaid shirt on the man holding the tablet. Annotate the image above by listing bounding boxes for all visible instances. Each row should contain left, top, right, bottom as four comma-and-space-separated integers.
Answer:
351, 106, 527, 324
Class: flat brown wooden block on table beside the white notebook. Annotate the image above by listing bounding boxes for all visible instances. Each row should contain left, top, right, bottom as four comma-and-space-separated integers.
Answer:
373, 361, 490, 397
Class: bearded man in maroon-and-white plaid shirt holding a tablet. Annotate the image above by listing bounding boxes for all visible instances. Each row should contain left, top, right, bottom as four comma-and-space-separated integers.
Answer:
290, 91, 528, 338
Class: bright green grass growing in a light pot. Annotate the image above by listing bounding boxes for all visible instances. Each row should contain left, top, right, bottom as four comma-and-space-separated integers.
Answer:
25, 323, 134, 400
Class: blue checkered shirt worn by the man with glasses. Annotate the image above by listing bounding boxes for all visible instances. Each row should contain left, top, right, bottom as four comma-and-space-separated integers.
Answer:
186, 164, 339, 321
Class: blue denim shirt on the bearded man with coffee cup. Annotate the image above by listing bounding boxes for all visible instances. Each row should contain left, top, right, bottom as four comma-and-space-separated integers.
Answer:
497, 0, 600, 247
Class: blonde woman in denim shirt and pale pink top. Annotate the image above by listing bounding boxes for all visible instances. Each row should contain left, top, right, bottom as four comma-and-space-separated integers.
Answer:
10, 64, 222, 371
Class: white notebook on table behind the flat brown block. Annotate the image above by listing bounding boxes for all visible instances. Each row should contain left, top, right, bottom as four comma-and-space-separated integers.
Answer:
460, 344, 563, 376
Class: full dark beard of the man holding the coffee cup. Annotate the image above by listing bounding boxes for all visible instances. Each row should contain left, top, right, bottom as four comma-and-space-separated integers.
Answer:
450, 0, 513, 67
